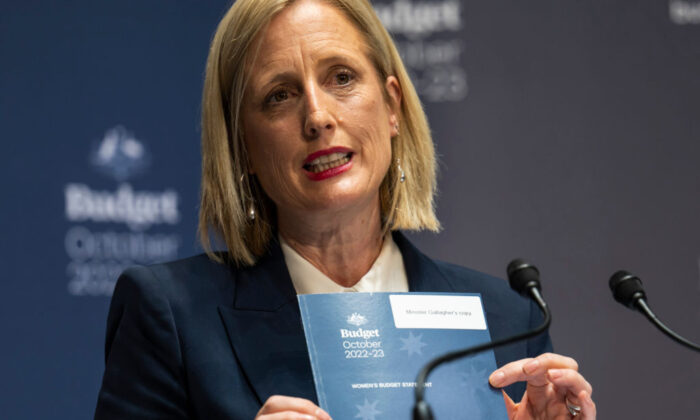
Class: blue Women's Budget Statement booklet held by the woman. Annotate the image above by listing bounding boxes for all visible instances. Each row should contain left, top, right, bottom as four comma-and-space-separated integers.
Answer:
298, 293, 508, 420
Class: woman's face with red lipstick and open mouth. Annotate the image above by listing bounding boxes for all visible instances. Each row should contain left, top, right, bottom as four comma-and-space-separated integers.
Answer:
242, 1, 400, 223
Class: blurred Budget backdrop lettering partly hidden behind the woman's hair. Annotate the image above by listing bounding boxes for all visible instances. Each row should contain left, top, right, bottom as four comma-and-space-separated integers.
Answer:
373, 0, 467, 102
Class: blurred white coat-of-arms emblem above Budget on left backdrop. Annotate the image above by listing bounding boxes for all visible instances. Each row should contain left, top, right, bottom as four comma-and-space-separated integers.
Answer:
90, 125, 150, 181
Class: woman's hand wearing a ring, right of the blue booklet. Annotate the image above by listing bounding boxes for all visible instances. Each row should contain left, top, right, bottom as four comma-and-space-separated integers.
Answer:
489, 353, 596, 420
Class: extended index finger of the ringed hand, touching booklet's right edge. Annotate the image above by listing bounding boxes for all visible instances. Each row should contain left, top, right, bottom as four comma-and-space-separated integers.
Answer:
489, 353, 578, 388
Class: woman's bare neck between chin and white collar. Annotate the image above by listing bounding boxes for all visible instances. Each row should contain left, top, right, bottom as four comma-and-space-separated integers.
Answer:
278, 197, 383, 287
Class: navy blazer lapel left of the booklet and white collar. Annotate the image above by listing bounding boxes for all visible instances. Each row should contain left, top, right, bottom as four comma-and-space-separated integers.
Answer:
219, 241, 317, 404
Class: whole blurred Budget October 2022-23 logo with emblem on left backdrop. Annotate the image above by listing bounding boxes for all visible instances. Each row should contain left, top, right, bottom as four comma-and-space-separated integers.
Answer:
63, 126, 182, 296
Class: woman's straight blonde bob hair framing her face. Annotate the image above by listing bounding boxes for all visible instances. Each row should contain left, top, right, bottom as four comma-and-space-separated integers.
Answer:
199, 0, 440, 266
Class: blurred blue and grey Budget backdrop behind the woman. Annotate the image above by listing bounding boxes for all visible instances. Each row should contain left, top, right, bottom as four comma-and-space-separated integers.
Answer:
0, 0, 700, 420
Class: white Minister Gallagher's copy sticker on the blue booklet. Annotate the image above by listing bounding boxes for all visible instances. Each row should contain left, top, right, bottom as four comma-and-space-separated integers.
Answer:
389, 295, 486, 330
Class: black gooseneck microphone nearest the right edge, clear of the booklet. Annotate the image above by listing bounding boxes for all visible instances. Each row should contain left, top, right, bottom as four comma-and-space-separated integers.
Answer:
609, 270, 700, 351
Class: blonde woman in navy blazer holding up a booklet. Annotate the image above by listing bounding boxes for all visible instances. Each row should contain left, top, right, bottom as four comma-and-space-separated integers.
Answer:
95, 0, 596, 420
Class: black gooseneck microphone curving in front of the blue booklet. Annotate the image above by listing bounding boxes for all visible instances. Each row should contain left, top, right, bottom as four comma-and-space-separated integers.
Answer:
413, 259, 552, 420
